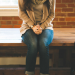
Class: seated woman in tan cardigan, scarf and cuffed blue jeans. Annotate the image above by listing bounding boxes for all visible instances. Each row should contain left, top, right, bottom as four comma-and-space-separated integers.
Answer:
18, 0, 56, 75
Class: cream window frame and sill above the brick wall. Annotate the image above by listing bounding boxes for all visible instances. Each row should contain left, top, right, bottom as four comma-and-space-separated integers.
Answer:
0, 5, 18, 16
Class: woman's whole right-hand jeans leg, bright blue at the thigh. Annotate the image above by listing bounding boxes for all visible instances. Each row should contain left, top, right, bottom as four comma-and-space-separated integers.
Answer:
38, 29, 54, 75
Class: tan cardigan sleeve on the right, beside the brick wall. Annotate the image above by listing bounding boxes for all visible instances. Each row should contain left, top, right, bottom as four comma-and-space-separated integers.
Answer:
41, 0, 56, 30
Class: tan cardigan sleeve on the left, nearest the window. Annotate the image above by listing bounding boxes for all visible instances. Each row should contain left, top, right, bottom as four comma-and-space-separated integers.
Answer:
18, 0, 34, 27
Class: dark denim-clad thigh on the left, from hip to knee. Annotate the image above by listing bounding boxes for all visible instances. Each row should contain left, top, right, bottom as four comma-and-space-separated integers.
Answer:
22, 29, 37, 45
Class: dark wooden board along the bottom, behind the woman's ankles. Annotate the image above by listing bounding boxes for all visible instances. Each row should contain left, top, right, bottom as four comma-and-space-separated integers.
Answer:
0, 67, 71, 75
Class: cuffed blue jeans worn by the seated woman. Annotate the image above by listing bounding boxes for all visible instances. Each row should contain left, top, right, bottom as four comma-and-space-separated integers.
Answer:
22, 29, 54, 75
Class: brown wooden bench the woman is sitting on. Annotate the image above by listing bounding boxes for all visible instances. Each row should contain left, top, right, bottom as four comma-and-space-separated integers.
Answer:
0, 28, 75, 75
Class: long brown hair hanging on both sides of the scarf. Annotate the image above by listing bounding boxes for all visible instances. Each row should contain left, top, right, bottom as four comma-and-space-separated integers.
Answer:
23, 0, 50, 11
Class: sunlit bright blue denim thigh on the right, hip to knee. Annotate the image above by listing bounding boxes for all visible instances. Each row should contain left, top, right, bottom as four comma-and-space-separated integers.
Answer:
39, 29, 54, 45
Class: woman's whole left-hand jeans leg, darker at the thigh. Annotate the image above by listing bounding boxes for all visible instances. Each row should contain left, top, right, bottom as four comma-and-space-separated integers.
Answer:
22, 29, 37, 75
